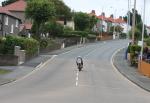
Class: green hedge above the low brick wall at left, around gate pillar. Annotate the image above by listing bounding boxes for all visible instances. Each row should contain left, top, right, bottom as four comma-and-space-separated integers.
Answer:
0, 36, 39, 56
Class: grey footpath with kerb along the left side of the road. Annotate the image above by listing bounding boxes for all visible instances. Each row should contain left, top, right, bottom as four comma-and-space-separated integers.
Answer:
0, 45, 84, 85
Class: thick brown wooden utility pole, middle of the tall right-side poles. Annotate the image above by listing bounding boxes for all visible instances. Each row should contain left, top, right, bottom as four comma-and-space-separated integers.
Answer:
132, 0, 136, 44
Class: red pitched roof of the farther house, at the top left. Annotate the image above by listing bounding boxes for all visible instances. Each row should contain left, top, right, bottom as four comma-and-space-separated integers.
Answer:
4, 0, 27, 11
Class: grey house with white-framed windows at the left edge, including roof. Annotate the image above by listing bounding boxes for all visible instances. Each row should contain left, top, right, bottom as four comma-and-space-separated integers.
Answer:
0, 7, 21, 36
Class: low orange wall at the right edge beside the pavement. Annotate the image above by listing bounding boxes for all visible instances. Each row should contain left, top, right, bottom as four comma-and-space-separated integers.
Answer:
138, 61, 150, 77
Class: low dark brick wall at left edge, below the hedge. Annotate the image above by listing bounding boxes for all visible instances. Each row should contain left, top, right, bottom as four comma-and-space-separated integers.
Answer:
0, 54, 19, 66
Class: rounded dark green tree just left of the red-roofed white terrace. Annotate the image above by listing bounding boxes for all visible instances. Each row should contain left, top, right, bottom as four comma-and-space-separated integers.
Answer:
74, 12, 90, 31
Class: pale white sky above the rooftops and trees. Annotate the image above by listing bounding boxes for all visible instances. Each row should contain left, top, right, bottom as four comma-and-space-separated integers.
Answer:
63, 0, 150, 26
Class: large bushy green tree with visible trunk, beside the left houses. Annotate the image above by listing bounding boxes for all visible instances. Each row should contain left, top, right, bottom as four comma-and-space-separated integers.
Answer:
25, 0, 55, 39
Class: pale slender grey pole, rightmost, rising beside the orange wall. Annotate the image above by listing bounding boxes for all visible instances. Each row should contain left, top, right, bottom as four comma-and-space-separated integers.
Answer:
141, 0, 146, 60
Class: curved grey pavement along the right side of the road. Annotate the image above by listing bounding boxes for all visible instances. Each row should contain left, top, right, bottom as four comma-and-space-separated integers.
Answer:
113, 48, 150, 92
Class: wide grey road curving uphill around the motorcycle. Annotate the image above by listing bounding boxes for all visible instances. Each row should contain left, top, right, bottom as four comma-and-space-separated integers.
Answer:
0, 40, 150, 103
